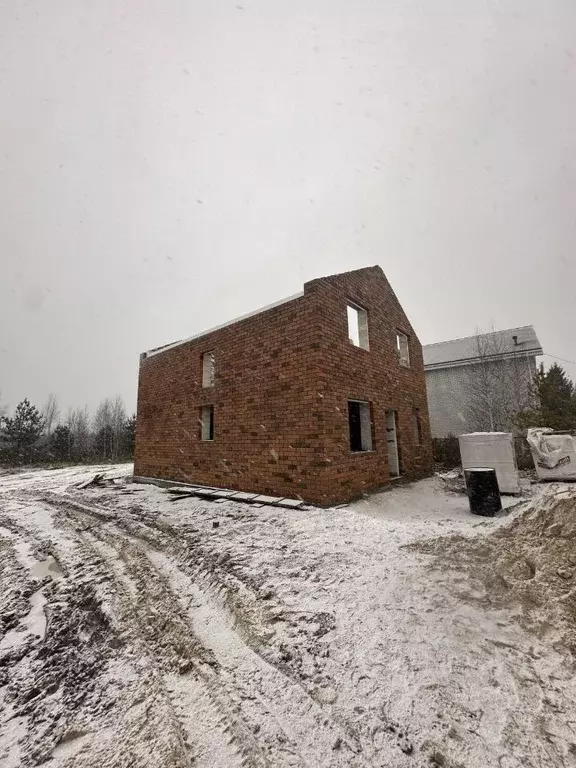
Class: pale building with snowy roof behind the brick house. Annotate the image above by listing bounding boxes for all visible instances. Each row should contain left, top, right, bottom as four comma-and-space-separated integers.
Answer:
422, 325, 543, 437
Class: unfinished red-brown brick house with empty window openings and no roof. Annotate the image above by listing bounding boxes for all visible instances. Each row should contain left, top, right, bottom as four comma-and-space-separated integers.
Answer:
134, 267, 432, 506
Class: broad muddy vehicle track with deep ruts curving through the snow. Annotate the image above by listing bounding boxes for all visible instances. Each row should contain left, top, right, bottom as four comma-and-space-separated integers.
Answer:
1, 494, 388, 768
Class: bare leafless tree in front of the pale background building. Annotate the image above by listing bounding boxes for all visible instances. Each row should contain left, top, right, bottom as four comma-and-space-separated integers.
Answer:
467, 329, 533, 432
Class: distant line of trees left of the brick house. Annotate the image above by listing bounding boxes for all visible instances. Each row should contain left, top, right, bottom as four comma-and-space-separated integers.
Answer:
0, 395, 136, 465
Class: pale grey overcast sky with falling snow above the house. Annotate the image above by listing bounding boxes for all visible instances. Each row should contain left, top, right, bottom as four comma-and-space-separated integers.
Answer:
0, 0, 576, 416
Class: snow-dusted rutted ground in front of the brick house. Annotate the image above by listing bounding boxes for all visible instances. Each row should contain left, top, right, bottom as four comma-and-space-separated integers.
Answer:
0, 465, 576, 768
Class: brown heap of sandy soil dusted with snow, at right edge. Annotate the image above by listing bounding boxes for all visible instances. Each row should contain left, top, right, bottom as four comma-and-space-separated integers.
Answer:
411, 485, 576, 655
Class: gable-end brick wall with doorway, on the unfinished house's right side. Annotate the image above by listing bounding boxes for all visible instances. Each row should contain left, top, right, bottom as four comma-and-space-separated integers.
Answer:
306, 267, 432, 502
